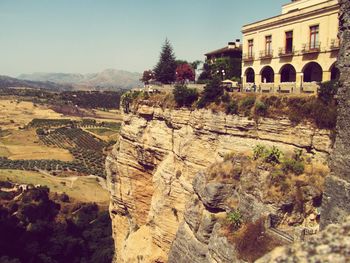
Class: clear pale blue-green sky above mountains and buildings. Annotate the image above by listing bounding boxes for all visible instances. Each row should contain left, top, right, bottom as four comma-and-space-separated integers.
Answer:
0, 0, 284, 77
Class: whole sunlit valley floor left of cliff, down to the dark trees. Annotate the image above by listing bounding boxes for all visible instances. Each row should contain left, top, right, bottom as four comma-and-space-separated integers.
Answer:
0, 89, 121, 206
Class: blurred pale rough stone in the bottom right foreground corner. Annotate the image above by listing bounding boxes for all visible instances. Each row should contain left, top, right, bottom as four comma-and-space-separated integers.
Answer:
256, 217, 350, 263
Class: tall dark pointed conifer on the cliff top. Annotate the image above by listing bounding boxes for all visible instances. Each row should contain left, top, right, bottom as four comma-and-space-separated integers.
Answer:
154, 39, 176, 84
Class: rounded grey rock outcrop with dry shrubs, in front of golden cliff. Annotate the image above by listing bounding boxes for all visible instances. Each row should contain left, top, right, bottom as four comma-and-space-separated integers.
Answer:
169, 155, 322, 263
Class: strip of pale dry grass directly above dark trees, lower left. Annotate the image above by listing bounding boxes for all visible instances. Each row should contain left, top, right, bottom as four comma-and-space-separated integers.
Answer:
0, 170, 109, 205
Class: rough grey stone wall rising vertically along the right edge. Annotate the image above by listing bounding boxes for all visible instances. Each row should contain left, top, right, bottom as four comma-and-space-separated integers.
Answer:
321, 0, 350, 228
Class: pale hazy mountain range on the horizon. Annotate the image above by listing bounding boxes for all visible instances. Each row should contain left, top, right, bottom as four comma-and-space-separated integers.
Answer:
18, 69, 141, 90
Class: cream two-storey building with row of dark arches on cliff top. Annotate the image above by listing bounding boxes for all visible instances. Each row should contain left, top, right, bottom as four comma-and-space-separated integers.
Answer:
242, 0, 339, 92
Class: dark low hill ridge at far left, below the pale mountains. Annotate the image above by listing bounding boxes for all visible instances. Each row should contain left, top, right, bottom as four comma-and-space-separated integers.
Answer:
0, 75, 73, 91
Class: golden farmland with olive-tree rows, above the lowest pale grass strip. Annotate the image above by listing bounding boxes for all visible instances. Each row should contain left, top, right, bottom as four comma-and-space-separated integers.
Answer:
0, 96, 121, 190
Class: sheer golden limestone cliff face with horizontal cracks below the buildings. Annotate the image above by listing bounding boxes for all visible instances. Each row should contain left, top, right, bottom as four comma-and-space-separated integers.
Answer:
106, 105, 331, 262
